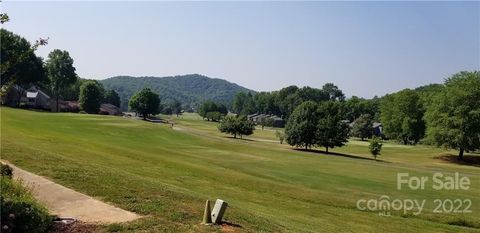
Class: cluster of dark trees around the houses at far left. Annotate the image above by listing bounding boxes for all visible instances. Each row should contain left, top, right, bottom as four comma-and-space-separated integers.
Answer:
0, 26, 120, 113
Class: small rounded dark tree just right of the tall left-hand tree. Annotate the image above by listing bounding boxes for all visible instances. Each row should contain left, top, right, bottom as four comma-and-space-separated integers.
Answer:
78, 80, 103, 113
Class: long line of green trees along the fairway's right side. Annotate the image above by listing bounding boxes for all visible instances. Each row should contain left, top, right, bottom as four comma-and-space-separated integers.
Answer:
215, 71, 480, 159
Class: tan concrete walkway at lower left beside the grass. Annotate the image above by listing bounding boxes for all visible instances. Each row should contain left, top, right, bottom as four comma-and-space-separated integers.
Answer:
7, 163, 141, 224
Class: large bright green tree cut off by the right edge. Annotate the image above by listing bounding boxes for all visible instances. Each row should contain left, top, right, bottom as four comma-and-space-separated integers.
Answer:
425, 71, 480, 160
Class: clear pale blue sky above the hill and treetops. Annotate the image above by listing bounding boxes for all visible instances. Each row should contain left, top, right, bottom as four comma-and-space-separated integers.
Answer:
2, 1, 480, 98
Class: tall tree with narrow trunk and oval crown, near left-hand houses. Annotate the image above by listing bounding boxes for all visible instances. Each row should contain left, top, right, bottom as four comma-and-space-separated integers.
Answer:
45, 49, 77, 111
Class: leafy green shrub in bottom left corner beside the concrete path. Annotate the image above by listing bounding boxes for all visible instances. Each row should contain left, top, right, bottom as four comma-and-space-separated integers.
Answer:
0, 179, 52, 233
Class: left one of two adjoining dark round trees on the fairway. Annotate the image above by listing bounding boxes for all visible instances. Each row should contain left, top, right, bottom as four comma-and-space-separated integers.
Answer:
285, 101, 318, 150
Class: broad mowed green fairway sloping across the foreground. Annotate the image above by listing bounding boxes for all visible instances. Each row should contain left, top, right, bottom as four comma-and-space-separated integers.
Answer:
1, 108, 480, 233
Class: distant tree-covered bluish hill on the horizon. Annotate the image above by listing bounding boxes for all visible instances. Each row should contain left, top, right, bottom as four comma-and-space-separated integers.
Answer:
100, 74, 254, 111
